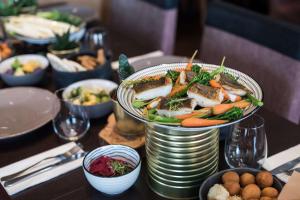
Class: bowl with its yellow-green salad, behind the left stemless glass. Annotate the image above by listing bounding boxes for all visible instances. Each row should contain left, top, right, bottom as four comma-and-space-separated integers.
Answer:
62, 79, 118, 118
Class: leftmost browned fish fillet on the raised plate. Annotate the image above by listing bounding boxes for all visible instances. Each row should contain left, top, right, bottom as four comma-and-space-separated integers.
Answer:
133, 77, 172, 100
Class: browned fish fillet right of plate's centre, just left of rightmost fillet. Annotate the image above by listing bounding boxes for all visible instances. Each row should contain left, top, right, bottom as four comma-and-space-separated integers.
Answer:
187, 83, 224, 107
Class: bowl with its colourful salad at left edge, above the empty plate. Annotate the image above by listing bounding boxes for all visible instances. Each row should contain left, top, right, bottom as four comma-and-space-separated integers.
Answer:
0, 54, 49, 86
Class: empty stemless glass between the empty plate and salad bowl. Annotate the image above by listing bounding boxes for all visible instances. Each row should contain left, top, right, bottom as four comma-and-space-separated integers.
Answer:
52, 89, 90, 141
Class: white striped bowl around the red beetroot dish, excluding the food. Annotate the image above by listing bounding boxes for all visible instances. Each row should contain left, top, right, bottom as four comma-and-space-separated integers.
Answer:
83, 145, 141, 195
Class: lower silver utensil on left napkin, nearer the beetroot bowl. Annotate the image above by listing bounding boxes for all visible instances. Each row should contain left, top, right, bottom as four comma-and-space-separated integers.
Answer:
3, 152, 87, 187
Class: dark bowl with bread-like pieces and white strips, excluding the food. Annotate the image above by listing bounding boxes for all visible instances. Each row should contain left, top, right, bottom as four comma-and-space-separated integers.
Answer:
52, 52, 112, 87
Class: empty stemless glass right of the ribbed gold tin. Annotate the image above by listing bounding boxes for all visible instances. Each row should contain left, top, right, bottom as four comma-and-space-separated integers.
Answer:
224, 115, 267, 169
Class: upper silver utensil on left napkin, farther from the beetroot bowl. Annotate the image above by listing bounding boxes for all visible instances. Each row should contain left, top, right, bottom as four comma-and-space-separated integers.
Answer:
0, 144, 81, 181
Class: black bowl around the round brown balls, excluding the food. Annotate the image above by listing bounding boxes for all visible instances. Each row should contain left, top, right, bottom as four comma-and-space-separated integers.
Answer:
199, 168, 282, 200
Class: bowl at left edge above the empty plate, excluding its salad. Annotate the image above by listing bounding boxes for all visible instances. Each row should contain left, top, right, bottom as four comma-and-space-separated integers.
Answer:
0, 54, 49, 86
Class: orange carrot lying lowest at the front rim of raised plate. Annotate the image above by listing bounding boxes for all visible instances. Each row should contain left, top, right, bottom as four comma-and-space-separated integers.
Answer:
181, 118, 228, 127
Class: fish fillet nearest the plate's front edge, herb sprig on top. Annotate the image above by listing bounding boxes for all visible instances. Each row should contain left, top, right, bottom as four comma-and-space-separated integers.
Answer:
156, 98, 197, 117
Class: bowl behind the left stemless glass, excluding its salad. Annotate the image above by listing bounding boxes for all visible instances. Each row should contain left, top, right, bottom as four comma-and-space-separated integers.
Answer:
62, 79, 118, 118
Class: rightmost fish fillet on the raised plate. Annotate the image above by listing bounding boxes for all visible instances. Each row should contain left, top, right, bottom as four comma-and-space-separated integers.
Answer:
220, 73, 248, 96
